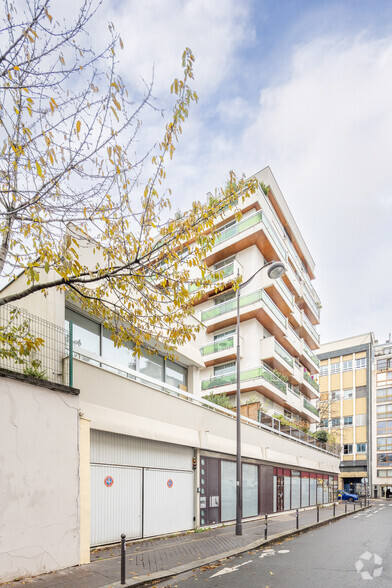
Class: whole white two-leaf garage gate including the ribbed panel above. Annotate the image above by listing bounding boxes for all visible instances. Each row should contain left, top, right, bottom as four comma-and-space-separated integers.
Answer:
90, 429, 195, 546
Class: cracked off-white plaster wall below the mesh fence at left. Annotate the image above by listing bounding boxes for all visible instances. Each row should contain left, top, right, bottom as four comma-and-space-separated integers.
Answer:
0, 377, 80, 582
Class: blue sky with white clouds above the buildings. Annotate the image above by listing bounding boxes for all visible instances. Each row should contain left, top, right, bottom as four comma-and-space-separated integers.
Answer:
73, 0, 392, 343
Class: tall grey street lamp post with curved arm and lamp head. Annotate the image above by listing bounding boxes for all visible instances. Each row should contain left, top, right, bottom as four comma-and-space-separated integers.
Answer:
235, 261, 286, 535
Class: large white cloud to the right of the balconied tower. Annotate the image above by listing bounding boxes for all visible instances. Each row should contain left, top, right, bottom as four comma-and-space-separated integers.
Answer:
237, 37, 392, 340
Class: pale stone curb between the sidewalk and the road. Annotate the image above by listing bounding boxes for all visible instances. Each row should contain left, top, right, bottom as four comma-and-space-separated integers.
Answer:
100, 504, 374, 588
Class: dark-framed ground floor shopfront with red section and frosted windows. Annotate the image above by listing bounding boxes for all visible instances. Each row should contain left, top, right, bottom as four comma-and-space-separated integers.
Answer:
199, 453, 338, 527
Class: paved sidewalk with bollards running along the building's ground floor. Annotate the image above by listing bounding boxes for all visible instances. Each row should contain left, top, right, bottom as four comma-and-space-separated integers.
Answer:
4, 503, 374, 588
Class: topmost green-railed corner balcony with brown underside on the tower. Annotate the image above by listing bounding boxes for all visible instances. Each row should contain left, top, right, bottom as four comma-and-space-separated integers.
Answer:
206, 210, 287, 266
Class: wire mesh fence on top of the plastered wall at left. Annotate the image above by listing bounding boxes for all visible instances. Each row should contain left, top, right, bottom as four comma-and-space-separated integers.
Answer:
0, 304, 72, 385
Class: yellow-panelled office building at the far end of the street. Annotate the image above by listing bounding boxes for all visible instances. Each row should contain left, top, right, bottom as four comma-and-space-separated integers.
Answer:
318, 333, 374, 494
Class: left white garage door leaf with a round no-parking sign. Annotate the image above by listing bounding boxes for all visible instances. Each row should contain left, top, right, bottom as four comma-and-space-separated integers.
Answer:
91, 464, 142, 545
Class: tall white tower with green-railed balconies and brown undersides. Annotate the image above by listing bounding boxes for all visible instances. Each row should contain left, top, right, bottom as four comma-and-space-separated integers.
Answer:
196, 168, 320, 426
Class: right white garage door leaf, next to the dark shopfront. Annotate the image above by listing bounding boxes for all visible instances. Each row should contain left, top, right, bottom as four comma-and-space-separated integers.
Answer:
143, 468, 194, 537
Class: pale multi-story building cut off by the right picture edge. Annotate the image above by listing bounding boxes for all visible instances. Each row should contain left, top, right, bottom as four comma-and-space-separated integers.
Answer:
372, 336, 392, 498
